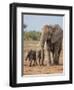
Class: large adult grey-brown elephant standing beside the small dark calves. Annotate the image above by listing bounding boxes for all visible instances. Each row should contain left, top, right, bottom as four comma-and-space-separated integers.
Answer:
40, 25, 63, 65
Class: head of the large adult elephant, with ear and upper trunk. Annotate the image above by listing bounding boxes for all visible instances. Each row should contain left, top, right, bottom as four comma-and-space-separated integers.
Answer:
41, 24, 63, 47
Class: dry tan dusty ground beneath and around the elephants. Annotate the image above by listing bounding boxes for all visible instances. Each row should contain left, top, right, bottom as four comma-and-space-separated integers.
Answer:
23, 41, 63, 75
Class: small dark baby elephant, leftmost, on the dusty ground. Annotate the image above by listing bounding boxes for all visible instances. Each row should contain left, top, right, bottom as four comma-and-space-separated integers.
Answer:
26, 50, 37, 67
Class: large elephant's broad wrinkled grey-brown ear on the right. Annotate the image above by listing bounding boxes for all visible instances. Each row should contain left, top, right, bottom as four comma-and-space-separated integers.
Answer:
51, 25, 63, 43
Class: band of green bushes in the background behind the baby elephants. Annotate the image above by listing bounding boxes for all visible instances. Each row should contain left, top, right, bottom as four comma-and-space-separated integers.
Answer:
24, 31, 41, 41
